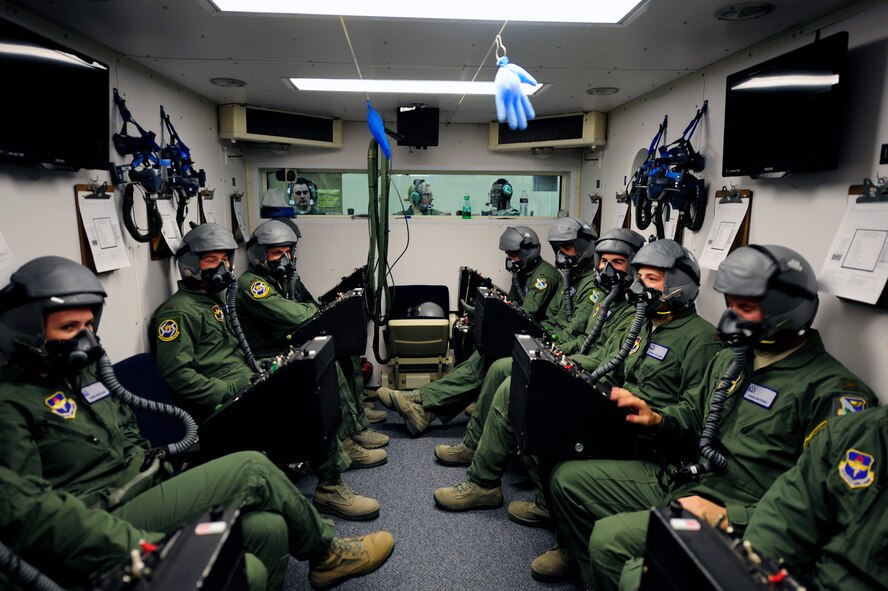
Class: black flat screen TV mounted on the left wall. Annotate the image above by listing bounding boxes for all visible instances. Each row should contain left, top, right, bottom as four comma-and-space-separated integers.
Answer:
0, 18, 111, 170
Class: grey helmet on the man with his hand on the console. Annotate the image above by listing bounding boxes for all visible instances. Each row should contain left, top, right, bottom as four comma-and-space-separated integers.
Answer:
713, 244, 820, 342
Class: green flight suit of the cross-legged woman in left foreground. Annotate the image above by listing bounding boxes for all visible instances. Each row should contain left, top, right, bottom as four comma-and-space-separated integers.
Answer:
0, 367, 333, 589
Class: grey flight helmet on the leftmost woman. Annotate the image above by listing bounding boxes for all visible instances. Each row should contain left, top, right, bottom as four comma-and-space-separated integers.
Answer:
0, 256, 107, 359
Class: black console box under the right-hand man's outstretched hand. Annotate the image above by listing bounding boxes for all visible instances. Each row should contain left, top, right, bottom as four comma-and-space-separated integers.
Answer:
509, 335, 638, 459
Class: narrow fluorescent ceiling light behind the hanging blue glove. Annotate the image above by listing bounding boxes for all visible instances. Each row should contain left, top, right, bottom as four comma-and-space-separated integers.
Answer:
289, 78, 546, 96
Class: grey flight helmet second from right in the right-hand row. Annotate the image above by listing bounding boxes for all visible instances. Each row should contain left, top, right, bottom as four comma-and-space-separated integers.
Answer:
632, 239, 700, 312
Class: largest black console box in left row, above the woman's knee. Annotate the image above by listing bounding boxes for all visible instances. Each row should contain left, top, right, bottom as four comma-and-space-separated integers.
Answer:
198, 336, 341, 464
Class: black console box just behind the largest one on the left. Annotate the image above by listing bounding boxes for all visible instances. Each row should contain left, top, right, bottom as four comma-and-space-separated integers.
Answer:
290, 288, 370, 357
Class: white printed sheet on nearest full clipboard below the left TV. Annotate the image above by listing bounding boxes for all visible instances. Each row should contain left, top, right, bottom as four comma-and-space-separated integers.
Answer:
77, 191, 130, 273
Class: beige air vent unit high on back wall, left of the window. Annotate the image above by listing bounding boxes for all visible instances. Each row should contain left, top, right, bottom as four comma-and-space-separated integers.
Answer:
219, 105, 342, 148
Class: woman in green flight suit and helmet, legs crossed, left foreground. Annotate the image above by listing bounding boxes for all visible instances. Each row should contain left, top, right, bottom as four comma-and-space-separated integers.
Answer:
0, 256, 394, 589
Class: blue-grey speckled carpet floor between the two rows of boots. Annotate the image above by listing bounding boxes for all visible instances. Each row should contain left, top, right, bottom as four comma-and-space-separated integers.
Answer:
284, 402, 574, 591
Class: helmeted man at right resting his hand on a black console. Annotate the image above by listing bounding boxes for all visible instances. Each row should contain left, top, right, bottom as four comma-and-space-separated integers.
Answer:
531, 243, 876, 589
